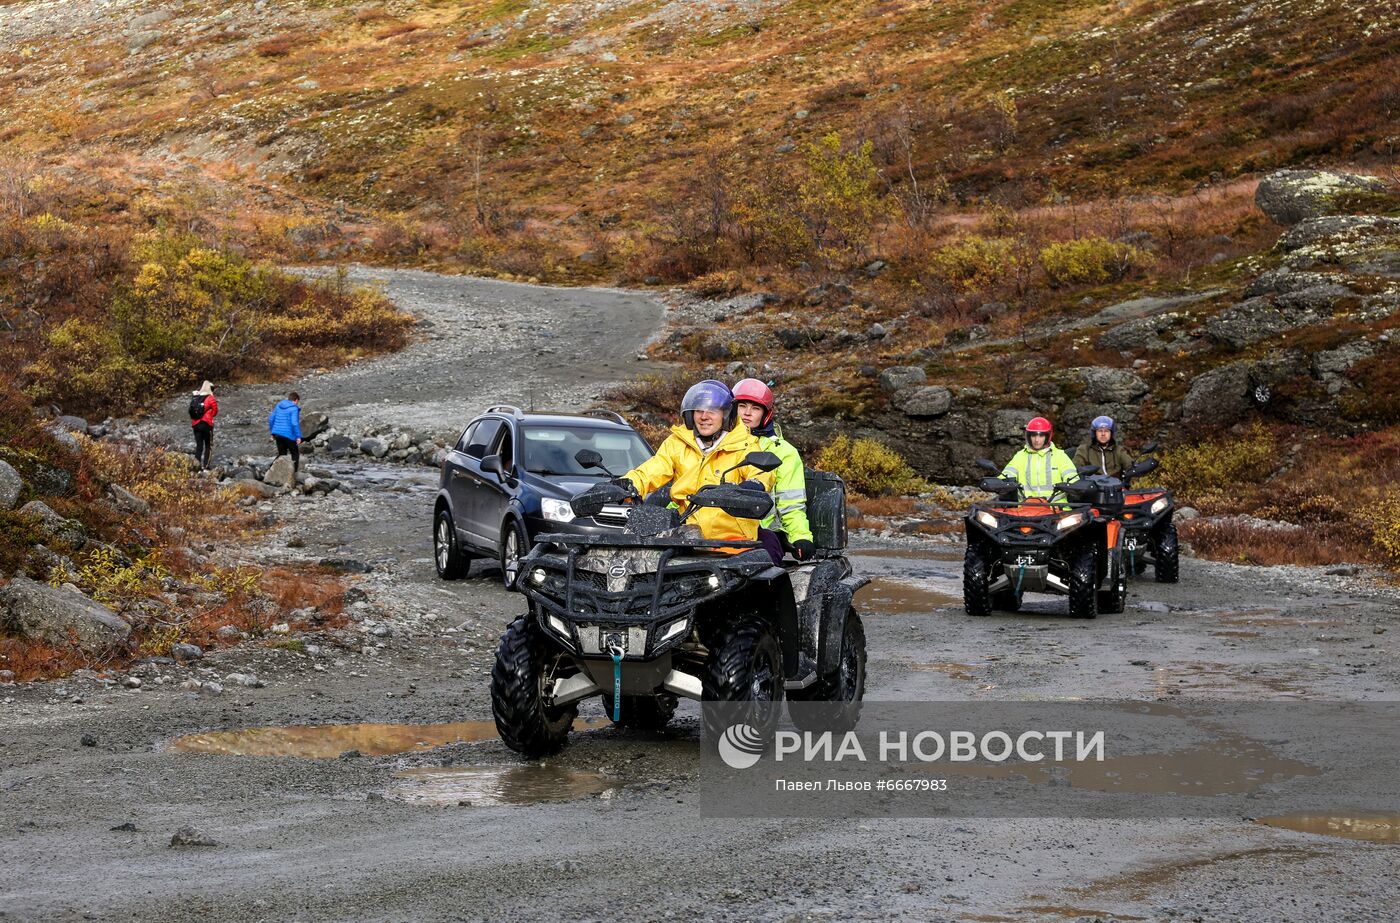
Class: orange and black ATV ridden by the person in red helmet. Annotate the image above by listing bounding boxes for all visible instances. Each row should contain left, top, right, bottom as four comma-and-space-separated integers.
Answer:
963, 458, 1127, 619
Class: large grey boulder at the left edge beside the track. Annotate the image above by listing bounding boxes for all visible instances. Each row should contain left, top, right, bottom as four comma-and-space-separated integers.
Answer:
0, 577, 132, 654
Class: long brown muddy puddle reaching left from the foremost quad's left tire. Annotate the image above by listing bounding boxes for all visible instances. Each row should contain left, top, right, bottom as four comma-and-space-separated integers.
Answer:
172, 719, 609, 759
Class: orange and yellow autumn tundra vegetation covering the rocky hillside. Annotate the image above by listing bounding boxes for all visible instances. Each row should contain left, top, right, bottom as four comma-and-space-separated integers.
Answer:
0, 0, 1400, 677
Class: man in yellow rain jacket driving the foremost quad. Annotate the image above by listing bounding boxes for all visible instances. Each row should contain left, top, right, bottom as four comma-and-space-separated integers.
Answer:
623, 380, 773, 542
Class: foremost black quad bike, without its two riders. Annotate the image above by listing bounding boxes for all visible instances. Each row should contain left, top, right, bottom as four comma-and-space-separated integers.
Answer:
491, 450, 867, 759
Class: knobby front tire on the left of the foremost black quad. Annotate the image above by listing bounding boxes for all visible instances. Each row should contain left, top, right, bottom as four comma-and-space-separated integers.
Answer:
491, 615, 578, 759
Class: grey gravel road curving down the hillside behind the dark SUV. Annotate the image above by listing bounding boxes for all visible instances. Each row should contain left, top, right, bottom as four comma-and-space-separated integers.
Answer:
150, 266, 664, 455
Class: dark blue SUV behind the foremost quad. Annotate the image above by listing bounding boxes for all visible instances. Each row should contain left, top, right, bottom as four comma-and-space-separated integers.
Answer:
433, 405, 652, 590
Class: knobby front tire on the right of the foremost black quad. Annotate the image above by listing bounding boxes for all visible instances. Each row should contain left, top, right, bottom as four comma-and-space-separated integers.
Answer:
701, 615, 783, 741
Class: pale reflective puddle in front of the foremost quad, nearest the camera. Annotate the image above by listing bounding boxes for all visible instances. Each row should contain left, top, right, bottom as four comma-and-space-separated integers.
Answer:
385, 765, 617, 808
